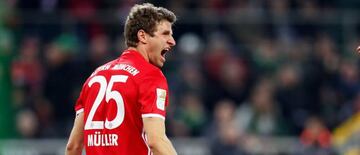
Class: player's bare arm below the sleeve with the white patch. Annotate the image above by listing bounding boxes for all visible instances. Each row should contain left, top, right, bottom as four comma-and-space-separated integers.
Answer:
143, 117, 177, 155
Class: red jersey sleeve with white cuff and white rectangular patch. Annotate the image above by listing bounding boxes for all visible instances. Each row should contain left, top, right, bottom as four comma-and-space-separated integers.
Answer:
139, 72, 169, 119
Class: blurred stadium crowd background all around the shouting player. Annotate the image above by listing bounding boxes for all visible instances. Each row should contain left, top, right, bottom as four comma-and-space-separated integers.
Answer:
0, 0, 360, 155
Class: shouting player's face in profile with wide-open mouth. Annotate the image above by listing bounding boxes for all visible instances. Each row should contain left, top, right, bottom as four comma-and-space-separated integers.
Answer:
148, 20, 176, 68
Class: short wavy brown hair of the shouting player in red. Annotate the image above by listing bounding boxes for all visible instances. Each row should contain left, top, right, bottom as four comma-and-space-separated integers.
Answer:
124, 3, 176, 47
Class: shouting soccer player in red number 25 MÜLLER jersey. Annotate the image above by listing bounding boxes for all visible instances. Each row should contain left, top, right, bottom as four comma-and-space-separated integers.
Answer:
66, 3, 176, 155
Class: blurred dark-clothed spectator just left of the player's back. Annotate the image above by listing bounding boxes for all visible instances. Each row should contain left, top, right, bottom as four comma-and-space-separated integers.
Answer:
43, 34, 81, 136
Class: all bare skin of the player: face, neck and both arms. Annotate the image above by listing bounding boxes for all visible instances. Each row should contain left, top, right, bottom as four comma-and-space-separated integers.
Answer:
65, 20, 177, 155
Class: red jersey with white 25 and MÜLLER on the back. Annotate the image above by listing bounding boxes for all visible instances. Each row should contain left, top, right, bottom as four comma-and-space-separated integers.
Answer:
75, 50, 169, 155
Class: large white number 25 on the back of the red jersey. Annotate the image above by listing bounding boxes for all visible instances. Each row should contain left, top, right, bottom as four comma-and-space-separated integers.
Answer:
84, 75, 128, 130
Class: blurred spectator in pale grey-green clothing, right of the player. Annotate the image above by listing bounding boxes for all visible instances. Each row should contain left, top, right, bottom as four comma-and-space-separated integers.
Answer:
236, 79, 291, 137
